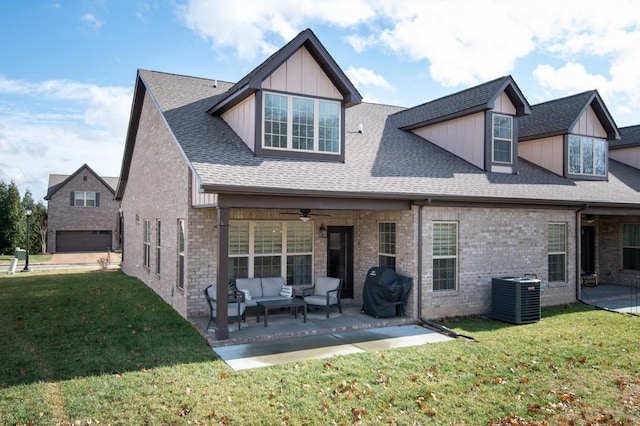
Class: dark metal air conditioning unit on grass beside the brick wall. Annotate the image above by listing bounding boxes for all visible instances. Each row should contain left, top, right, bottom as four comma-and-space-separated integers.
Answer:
491, 277, 540, 324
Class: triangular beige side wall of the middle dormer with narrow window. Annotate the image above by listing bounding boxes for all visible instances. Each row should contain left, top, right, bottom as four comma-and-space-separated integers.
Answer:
412, 112, 485, 169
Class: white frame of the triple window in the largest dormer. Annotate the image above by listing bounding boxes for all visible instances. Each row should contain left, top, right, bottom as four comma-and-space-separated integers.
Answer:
260, 91, 342, 156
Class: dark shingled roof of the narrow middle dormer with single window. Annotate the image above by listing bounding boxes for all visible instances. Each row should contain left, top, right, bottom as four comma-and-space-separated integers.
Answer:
396, 76, 530, 129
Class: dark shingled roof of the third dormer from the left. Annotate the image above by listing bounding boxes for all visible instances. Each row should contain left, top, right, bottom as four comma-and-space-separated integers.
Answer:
518, 90, 618, 141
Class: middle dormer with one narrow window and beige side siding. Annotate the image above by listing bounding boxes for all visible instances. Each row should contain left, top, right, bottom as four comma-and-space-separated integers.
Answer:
395, 76, 531, 173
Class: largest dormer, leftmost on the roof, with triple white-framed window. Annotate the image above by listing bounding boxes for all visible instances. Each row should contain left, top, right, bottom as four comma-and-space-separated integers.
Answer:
207, 29, 362, 162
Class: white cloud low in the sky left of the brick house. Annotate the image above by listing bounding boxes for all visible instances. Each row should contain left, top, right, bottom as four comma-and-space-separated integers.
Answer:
0, 77, 131, 199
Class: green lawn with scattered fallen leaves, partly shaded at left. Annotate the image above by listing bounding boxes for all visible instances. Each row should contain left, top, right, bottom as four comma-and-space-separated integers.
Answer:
0, 272, 640, 426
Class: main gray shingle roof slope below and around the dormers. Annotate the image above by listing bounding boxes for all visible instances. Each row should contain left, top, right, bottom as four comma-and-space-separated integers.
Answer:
140, 71, 640, 206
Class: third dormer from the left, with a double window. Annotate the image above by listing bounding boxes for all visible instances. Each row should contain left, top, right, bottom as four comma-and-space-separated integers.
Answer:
519, 90, 620, 180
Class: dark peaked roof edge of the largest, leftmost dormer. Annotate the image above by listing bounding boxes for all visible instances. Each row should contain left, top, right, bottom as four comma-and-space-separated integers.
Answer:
207, 28, 362, 114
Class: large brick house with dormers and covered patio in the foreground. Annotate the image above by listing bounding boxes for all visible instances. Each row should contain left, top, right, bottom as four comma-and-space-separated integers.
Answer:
116, 30, 640, 339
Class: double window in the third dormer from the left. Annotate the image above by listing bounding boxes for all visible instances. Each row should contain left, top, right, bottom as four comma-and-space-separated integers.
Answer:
569, 135, 607, 176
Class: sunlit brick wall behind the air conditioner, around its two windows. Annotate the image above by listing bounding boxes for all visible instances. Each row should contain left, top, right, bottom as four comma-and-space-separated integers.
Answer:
422, 207, 576, 319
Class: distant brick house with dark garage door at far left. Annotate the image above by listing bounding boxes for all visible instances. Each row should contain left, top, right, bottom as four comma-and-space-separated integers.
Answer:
44, 164, 120, 253
